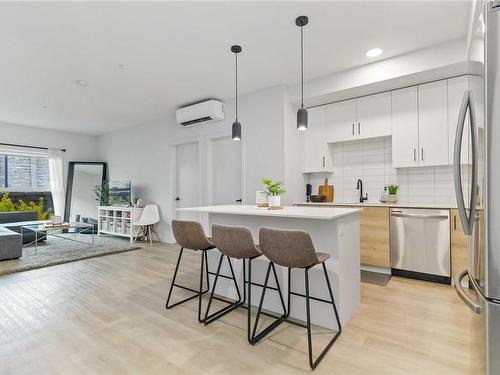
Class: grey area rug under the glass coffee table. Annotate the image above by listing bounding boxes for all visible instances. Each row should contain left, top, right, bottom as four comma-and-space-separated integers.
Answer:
0, 236, 141, 276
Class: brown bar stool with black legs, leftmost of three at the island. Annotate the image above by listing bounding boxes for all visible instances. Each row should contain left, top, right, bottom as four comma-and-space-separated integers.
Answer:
165, 220, 215, 323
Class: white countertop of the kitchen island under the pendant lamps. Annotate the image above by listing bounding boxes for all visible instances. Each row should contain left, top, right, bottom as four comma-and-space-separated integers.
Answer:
177, 205, 361, 220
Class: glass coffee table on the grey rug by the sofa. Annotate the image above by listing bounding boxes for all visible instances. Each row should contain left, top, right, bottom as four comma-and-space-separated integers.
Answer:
21, 222, 95, 253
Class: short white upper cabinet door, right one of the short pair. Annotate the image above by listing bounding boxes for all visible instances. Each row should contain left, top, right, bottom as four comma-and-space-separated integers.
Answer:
355, 92, 391, 139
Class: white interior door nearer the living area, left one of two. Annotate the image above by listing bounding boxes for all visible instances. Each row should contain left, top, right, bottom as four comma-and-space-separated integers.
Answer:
174, 143, 200, 221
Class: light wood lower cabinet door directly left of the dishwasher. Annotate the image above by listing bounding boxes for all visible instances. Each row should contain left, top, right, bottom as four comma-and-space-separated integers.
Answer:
360, 207, 391, 268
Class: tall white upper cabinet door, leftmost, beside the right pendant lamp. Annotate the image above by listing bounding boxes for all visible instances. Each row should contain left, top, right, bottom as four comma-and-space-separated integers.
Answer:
302, 106, 332, 173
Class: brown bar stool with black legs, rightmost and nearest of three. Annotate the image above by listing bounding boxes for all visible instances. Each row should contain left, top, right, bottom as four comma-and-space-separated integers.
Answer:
252, 228, 342, 370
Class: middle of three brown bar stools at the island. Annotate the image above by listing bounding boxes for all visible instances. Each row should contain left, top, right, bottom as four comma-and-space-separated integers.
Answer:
205, 224, 268, 342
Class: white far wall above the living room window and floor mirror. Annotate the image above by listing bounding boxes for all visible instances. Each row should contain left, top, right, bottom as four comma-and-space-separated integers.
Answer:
0, 122, 98, 184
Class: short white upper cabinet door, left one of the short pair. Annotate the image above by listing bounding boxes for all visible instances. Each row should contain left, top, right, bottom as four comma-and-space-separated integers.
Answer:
326, 99, 358, 142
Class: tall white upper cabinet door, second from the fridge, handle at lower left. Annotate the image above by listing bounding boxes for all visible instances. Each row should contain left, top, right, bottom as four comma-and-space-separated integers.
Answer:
418, 80, 449, 166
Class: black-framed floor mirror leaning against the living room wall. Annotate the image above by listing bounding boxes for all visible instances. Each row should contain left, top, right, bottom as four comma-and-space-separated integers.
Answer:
64, 161, 106, 228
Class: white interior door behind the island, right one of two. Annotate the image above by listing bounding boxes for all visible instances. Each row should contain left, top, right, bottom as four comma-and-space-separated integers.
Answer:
212, 137, 242, 205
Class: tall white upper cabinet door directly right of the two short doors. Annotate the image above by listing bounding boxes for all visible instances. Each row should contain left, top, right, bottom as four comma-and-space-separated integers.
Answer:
392, 86, 419, 168
